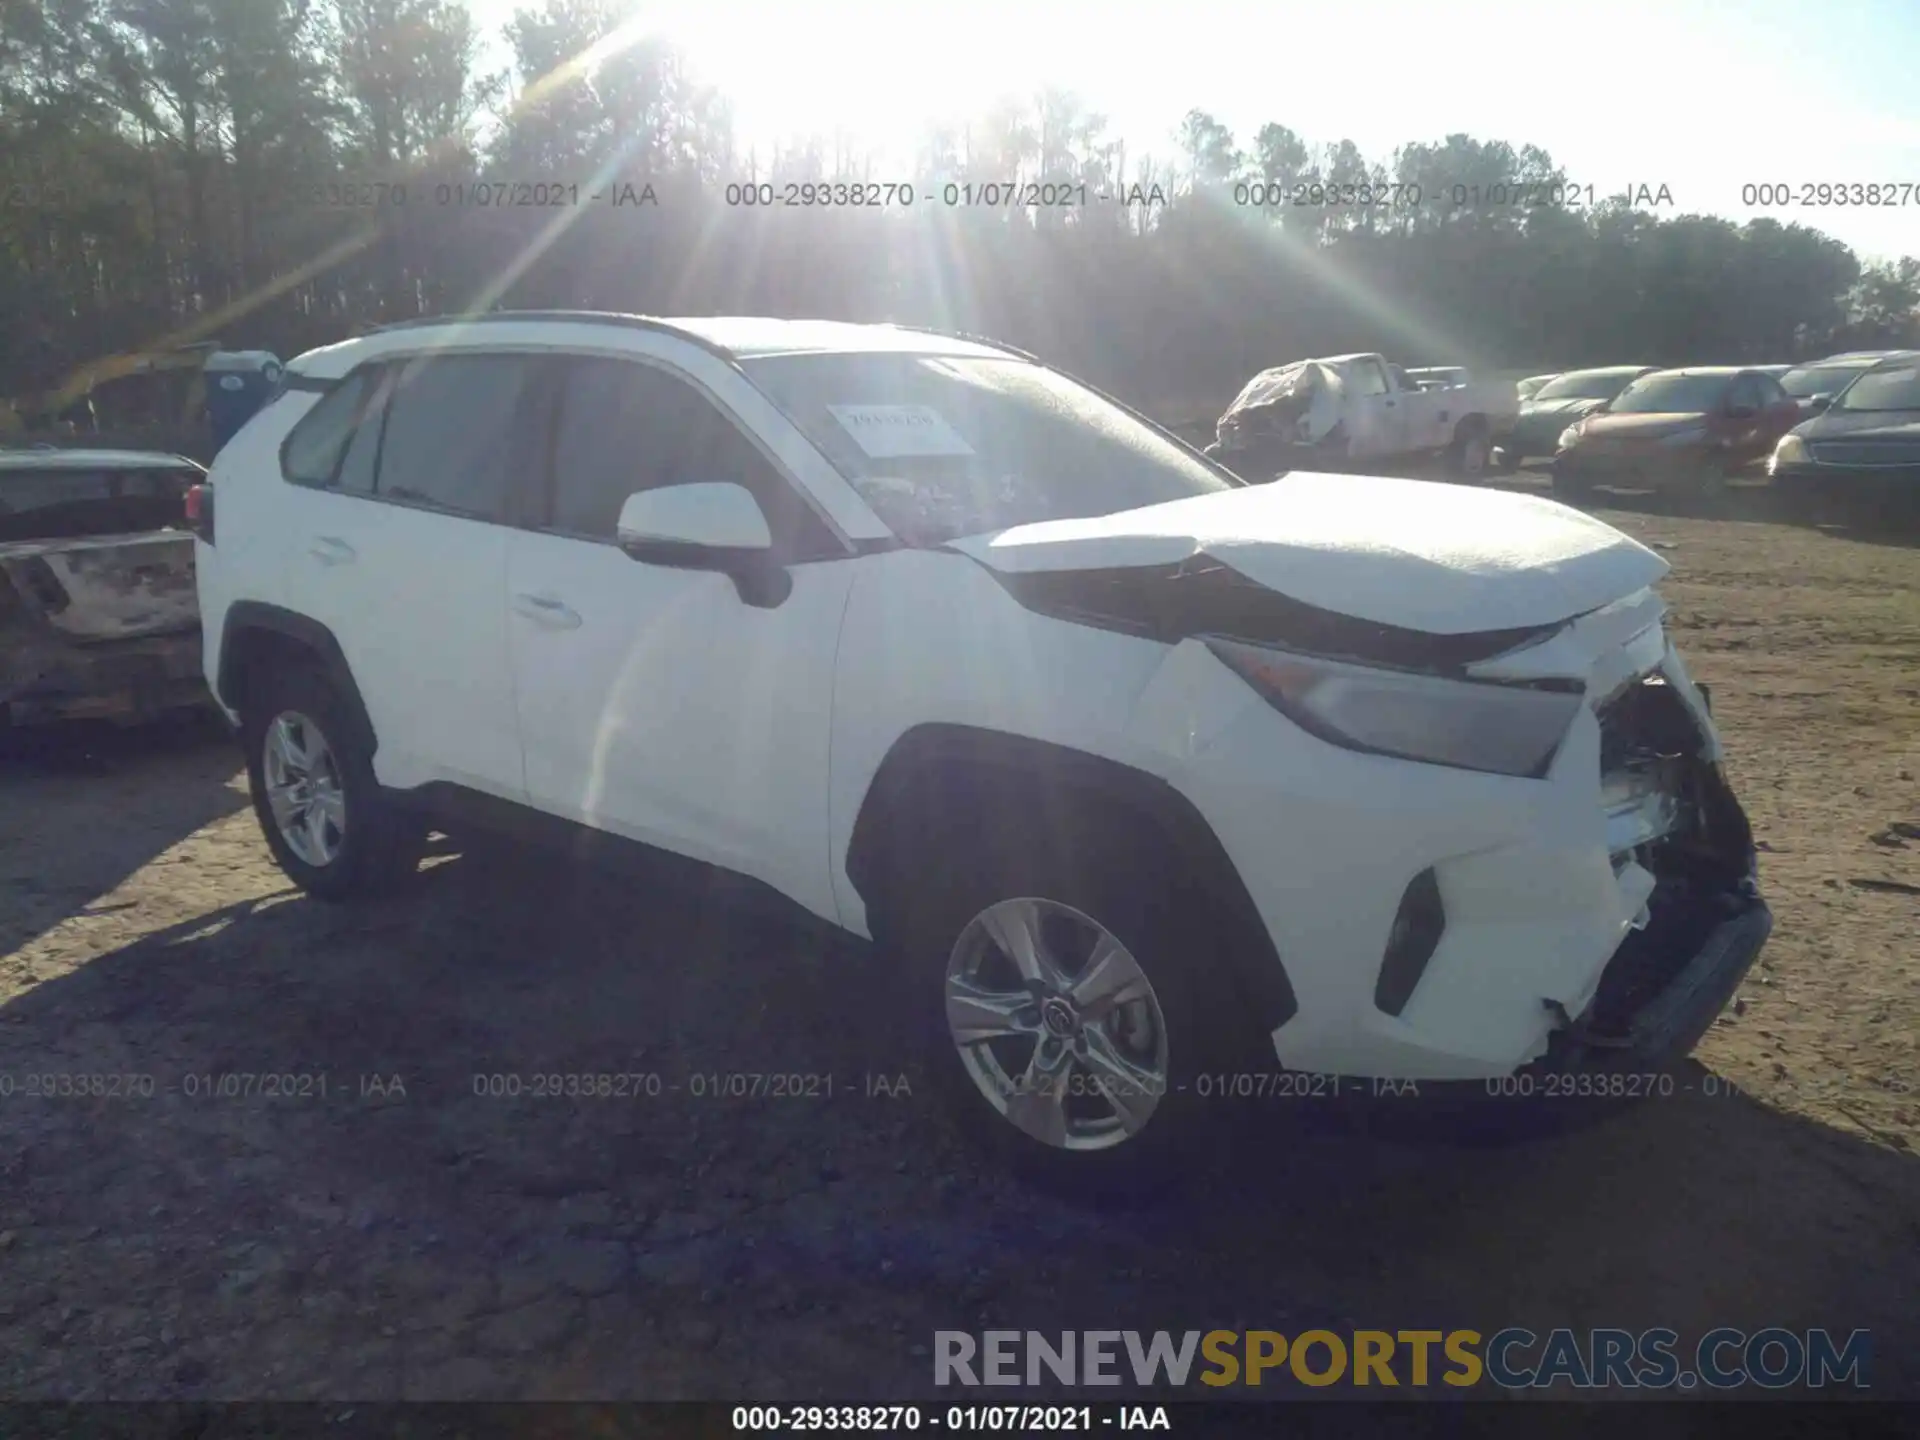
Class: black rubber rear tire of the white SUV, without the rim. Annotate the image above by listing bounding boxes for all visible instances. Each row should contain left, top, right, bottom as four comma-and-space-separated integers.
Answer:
240, 668, 426, 900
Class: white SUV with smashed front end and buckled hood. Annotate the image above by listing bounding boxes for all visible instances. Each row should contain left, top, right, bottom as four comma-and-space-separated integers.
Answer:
194, 313, 1770, 1187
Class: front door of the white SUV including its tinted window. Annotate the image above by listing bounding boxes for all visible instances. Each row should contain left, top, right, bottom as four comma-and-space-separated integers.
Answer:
507, 357, 858, 918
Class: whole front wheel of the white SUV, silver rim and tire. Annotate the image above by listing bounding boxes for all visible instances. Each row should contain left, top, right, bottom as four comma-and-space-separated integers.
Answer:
885, 824, 1251, 1202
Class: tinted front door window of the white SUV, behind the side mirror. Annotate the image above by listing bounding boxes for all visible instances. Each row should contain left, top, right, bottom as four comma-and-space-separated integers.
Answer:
551, 359, 839, 559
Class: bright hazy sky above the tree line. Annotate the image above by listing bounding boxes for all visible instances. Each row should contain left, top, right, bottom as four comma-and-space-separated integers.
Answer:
467, 0, 1920, 259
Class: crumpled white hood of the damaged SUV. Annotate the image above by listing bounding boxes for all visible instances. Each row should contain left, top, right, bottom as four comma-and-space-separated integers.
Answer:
950, 470, 1667, 636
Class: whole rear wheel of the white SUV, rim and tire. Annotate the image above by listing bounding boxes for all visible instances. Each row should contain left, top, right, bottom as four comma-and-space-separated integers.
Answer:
240, 668, 426, 900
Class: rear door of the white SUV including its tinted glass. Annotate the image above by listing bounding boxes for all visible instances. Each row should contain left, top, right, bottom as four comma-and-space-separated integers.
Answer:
270, 353, 551, 799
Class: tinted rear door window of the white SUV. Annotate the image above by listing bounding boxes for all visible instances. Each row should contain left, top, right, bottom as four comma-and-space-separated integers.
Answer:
378, 355, 545, 520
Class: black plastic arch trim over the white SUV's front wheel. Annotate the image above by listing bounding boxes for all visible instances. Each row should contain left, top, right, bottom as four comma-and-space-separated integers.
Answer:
847, 724, 1298, 1033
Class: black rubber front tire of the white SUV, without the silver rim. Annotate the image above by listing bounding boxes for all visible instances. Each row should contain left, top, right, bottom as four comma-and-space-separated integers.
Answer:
883, 824, 1277, 1204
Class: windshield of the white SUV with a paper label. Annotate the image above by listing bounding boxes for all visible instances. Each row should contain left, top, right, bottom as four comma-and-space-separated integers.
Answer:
741, 353, 1235, 545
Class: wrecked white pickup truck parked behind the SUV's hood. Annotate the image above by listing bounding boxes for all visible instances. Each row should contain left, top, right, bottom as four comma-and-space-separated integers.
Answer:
1206, 355, 1519, 480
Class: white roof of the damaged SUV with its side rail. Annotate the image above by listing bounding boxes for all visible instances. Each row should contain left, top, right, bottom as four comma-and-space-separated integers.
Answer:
288, 313, 1006, 378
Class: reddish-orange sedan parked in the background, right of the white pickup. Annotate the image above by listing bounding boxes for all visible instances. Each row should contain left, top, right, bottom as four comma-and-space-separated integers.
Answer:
1553, 365, 1799, 495
